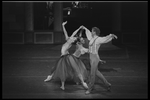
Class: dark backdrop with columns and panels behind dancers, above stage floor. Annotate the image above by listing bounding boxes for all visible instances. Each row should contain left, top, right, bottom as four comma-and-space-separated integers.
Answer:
2, 2, 148, 45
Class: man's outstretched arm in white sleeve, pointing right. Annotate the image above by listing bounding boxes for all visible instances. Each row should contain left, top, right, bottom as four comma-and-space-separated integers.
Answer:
98, 34, 117, 44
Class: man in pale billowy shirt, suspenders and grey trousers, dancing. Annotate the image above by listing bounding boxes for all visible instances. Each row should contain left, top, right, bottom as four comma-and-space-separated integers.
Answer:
82, 26, 117, 94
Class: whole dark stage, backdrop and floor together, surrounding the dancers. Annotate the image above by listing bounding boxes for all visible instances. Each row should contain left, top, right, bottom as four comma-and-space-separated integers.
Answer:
2, 1, 148, 99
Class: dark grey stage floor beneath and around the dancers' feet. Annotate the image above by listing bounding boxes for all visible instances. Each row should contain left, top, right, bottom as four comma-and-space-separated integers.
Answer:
2, 45, 148, 99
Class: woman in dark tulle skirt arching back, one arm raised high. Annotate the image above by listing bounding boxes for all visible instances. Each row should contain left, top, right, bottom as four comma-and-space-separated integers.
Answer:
44, 21, 88, 90
